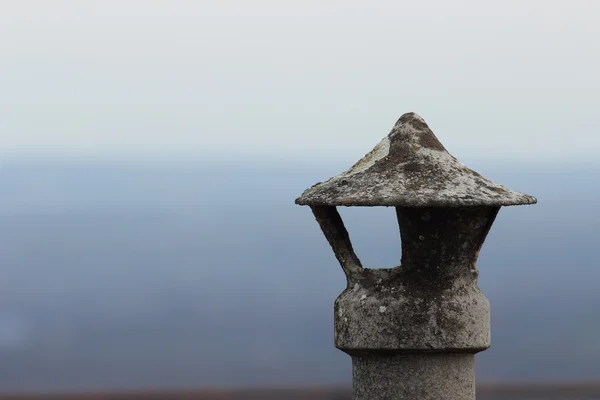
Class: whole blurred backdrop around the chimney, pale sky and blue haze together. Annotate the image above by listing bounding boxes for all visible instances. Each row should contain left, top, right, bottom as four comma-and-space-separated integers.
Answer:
0, 0, 600, 398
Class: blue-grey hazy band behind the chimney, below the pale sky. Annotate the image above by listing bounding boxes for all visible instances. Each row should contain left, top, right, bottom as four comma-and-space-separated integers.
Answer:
0, 163, 600, 389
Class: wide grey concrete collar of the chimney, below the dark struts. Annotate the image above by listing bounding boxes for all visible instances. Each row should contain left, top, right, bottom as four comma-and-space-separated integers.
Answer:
334, 280, 490, 355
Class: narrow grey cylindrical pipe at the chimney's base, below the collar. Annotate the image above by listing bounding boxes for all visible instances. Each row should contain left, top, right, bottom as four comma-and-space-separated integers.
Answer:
352, 354, 475, 400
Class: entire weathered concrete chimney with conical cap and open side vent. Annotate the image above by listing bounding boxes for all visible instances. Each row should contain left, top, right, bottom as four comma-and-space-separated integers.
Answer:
296, 113, 537, 400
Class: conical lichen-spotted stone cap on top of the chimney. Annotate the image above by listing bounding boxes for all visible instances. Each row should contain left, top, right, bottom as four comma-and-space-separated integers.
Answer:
296, 113, 537, 207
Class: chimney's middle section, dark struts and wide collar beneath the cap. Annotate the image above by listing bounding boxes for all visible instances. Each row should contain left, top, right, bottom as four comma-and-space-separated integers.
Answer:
330, 207, 498, 355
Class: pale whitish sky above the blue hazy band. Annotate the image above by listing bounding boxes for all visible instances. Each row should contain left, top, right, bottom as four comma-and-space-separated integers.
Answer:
0, 0, 600, 162
